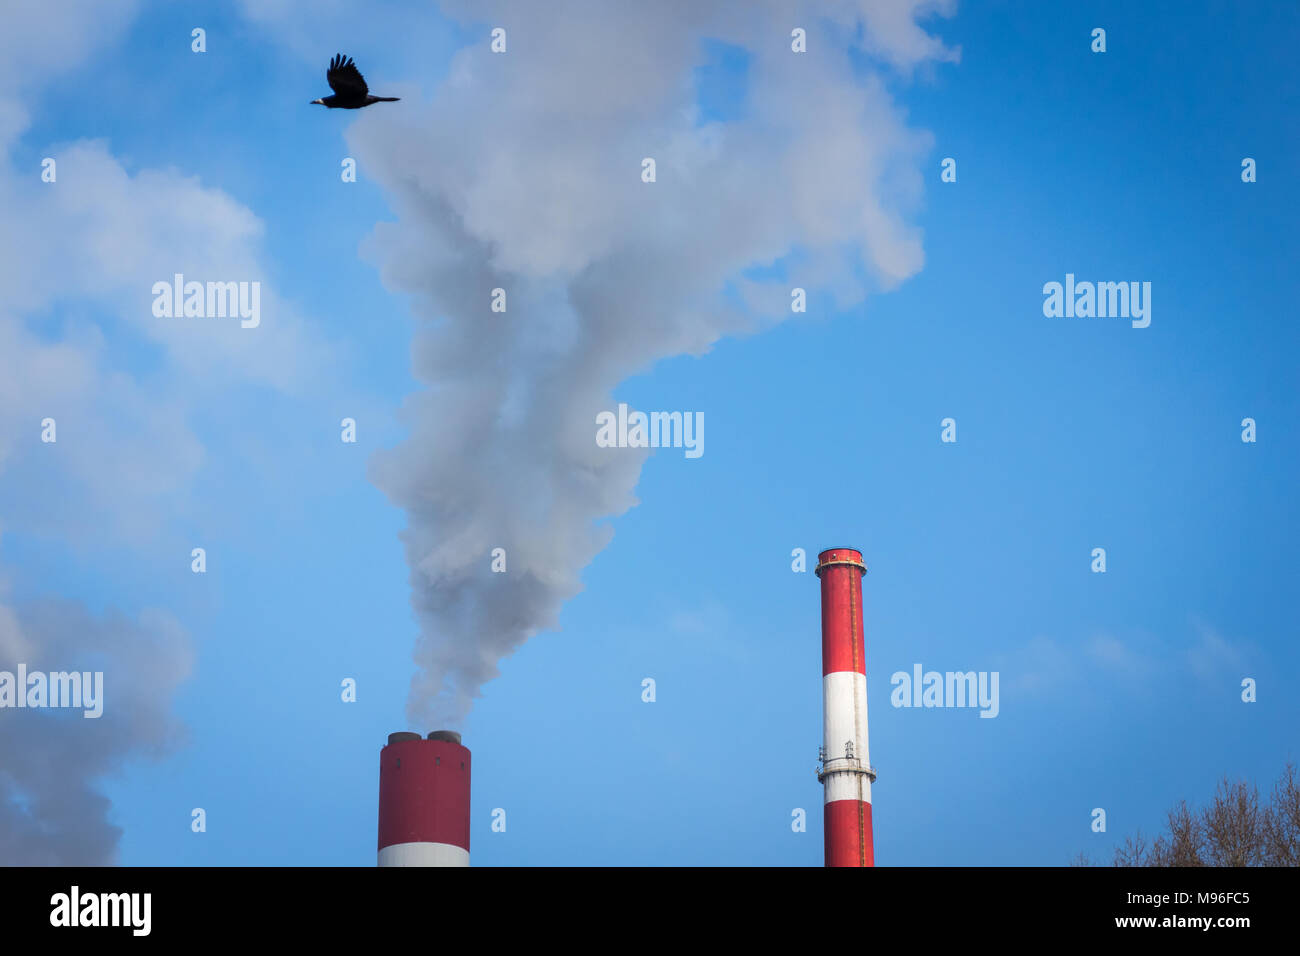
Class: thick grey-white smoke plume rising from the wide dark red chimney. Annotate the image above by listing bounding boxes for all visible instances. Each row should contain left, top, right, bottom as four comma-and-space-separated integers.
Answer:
348, 0, 956, 727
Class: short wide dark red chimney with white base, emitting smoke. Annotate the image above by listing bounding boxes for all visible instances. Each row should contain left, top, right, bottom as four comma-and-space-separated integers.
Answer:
380, 730, 469, 866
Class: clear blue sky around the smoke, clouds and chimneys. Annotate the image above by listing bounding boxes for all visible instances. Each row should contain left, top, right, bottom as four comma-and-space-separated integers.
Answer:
0, 3, 1300, 866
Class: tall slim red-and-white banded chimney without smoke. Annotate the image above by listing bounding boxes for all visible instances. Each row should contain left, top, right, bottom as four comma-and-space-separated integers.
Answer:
816, 548, 876, 866
